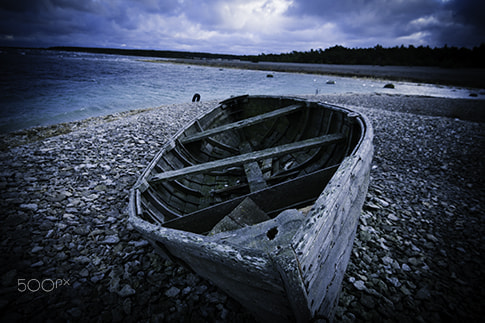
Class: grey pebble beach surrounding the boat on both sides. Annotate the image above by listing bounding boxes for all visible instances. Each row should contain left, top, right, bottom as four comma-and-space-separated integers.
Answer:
0, 94, 485, 322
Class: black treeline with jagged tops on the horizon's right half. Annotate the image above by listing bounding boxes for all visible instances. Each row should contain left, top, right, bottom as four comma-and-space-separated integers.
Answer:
245, 43, 485, 68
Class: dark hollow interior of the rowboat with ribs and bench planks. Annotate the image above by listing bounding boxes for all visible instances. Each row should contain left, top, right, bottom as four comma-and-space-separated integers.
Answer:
137, 96, 363, 234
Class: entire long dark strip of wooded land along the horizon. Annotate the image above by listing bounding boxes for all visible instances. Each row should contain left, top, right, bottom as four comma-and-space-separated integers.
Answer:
48, 43, 485, 68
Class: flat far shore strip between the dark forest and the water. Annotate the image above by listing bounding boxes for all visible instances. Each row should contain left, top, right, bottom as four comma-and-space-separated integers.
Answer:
148, 59, 485, 90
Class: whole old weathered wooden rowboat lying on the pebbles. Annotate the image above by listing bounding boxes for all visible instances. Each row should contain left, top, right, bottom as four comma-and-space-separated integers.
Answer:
129, 96, 373, 322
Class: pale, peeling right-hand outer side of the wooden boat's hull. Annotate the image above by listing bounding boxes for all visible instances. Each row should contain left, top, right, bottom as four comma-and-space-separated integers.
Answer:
293, 117, 373, 320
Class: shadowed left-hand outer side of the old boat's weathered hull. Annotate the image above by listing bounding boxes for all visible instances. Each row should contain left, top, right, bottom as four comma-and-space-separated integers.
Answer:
133, 209, 292, 322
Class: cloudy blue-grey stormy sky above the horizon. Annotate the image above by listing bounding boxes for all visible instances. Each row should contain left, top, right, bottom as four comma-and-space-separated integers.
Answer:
0, 0, 485, 54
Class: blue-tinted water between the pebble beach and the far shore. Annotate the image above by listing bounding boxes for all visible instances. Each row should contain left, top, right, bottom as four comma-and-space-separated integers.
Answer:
0, 49, 480, 132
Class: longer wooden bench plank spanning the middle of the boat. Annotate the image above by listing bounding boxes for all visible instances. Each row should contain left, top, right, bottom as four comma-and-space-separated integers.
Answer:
148, 133, 345, 183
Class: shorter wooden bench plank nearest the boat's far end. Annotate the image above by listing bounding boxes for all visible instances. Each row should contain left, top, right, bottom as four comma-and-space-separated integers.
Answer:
180, 104, 303, 144
